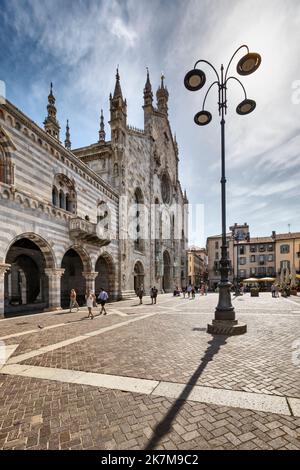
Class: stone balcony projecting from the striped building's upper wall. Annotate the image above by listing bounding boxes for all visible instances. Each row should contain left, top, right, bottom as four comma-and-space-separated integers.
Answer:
69, 217, 112, 246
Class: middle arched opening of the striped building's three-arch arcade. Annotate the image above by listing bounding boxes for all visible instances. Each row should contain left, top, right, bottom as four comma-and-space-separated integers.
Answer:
61, 248, 85, 308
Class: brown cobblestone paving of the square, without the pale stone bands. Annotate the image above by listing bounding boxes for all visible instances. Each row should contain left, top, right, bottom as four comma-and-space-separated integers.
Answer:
0, 294, 300, 449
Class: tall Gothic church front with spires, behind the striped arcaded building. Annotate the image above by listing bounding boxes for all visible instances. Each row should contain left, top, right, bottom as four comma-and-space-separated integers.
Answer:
73, 72, 188, 293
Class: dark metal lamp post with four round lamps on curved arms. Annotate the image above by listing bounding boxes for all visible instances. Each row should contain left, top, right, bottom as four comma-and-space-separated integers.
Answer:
184, 44, 261, 335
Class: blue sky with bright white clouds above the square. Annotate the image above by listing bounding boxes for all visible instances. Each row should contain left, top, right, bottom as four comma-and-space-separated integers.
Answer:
0, 0, 300, 245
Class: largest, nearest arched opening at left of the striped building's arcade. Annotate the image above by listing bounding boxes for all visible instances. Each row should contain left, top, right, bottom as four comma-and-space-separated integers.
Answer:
4, 239, 54, 315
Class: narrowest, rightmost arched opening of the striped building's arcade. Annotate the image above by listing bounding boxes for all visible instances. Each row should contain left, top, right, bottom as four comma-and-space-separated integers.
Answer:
95, 254, 116, 300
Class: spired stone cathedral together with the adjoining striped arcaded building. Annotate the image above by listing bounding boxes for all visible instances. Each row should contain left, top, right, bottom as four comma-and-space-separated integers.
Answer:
0, 70, 188, 317
